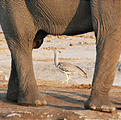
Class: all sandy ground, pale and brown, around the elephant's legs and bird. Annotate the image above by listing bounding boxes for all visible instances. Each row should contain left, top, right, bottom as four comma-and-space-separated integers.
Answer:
0, 33, 121, 120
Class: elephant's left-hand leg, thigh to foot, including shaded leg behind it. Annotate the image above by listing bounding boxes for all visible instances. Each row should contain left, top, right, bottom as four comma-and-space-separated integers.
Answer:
0, 0, 46, 106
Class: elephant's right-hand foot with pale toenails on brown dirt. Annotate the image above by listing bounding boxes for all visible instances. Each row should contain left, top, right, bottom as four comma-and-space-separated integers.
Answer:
84, 94, 116, 113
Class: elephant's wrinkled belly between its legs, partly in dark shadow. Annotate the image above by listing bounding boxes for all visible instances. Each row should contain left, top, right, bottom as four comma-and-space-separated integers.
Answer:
28, 0, 92, 35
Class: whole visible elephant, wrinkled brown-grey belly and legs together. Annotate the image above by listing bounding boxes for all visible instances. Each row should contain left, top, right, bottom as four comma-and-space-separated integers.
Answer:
0, 0, 121, 112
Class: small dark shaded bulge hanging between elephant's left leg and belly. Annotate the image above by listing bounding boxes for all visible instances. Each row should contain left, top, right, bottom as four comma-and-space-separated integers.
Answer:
32, 30, 47, 49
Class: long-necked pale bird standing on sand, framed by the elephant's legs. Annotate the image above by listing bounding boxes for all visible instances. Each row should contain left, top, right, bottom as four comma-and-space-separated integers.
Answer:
54, 49, 87, 84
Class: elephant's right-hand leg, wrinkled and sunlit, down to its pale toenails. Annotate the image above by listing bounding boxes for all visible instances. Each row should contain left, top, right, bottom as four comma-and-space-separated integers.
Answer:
85, 0, 121, 112
